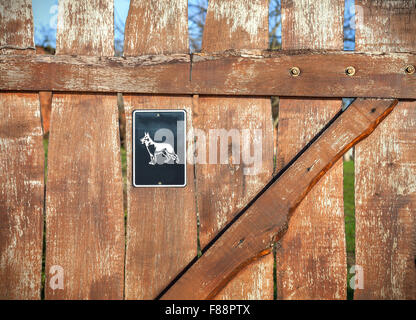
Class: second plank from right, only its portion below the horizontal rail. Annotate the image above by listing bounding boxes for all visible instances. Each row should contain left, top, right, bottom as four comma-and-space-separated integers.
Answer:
276, 99, 347, 299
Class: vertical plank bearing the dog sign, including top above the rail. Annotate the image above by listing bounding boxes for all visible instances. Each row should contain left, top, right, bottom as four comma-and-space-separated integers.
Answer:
124, 0, 197, 299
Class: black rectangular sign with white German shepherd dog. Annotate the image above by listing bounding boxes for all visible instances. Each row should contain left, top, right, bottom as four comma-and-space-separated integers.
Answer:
132, 110, 186, 187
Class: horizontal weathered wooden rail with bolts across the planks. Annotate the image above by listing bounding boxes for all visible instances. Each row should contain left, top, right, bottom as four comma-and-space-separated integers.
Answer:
0, 50, 416, 99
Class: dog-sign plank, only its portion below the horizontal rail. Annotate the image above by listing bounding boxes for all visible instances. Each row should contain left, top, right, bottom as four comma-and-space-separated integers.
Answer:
124, 96, 197, 299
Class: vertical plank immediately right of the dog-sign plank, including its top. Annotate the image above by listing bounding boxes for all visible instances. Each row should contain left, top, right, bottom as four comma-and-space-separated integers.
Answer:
194, 0, 273, 299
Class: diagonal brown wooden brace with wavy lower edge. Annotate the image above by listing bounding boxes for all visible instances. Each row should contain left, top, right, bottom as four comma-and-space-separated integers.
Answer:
161, 99, 397, 299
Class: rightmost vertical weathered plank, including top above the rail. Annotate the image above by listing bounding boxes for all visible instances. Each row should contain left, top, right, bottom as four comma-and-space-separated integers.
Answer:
354, 0, 416, 300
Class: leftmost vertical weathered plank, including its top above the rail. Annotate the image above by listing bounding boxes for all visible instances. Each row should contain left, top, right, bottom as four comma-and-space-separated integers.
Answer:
0, 0, 44, 299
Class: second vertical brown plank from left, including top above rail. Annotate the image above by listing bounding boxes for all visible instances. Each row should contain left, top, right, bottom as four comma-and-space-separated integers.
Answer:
45, 0, 125, 299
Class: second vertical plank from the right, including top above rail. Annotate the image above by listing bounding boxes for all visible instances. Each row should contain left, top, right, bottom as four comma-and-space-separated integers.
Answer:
276, 0, 347, 299
